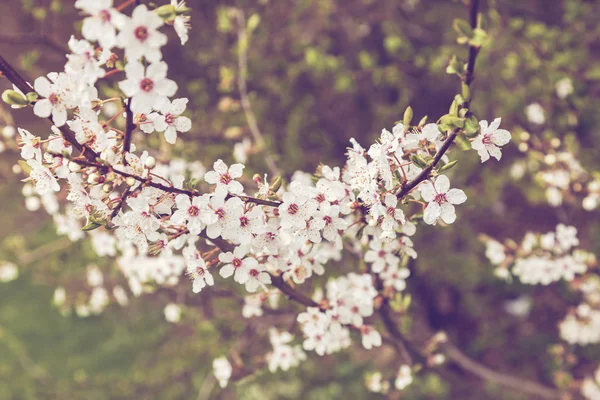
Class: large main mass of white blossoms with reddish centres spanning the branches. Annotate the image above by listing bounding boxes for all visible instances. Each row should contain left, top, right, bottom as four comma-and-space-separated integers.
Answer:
0, 0, 516, 394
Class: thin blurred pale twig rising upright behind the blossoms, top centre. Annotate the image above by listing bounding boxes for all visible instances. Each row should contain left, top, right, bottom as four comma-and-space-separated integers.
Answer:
237, 10, 281, 176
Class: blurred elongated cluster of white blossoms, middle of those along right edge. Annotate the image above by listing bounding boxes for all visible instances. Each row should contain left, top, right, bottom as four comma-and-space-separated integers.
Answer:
486, 224, 595, 285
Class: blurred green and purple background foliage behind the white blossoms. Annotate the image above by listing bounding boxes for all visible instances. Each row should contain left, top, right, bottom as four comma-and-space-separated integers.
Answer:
0, 0, 600, 400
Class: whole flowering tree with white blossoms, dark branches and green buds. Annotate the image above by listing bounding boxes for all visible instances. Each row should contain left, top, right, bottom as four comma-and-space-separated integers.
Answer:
0, 0, 600, 399
